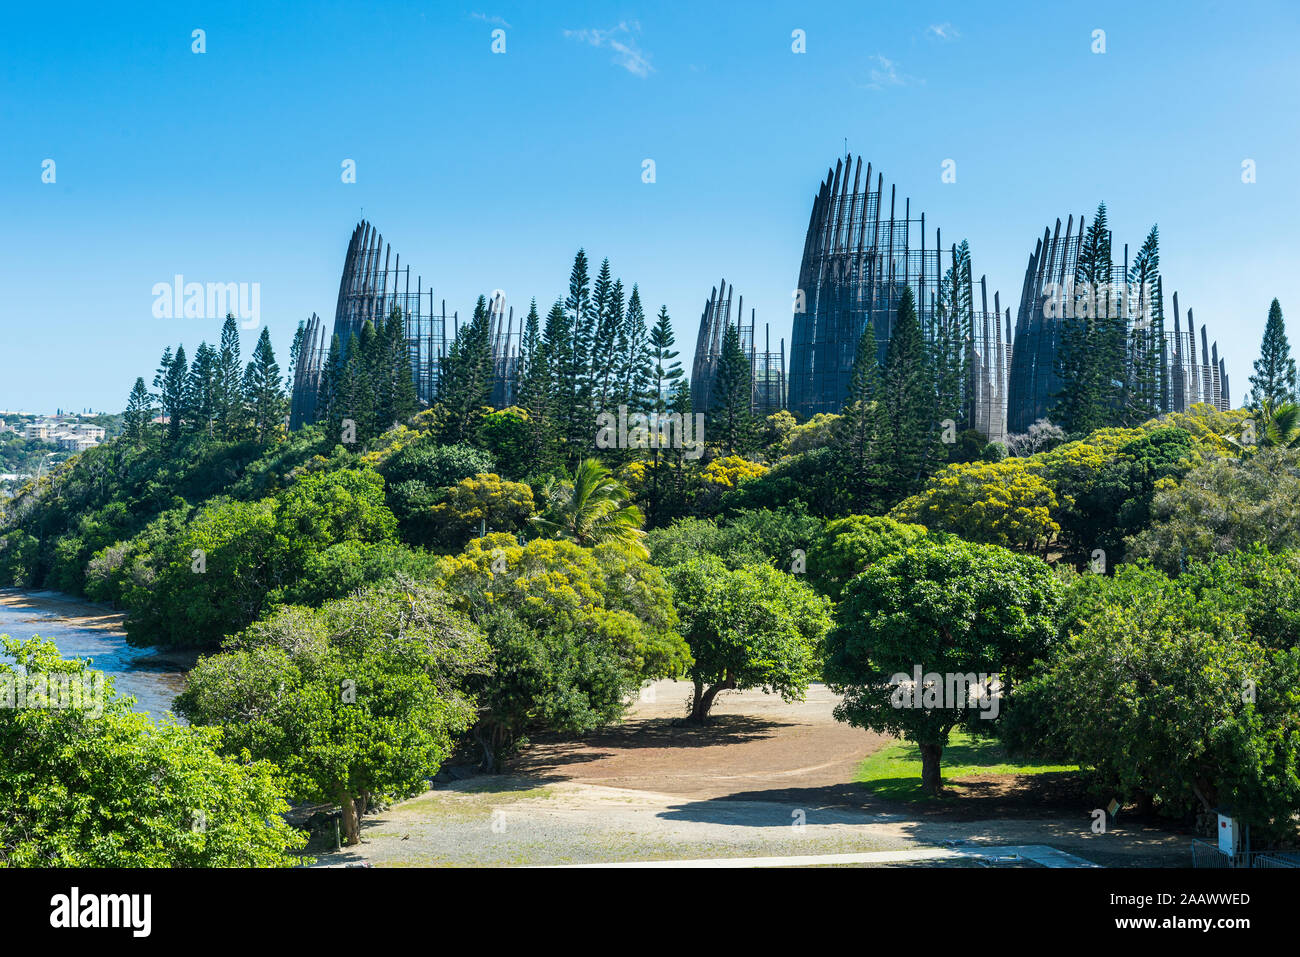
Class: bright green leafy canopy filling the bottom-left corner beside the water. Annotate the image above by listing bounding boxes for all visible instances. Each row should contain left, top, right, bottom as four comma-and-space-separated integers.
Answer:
0, 636, 306, 867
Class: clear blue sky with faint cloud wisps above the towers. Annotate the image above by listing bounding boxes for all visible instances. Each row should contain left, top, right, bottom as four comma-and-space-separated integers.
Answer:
0, 0, 1300, 411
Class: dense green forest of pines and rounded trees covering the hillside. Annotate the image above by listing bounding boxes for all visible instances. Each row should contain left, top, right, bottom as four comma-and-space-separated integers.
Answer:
0, 252, 1300, 863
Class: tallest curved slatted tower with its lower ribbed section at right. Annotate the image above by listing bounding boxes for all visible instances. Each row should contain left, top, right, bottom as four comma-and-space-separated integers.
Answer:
789, 156, 1011, 438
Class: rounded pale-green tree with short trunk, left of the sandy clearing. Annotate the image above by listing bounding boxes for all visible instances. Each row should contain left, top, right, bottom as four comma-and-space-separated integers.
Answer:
177, 583, 490, 844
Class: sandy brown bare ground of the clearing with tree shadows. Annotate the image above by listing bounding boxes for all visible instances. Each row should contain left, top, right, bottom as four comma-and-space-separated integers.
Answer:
319, 681, 1190, 866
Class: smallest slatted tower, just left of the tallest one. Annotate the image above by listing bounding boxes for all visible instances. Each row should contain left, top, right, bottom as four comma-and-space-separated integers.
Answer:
690, 278, 785, 416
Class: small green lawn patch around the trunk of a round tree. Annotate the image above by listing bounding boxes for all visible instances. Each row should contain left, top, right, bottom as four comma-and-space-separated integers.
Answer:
854, 731, 1079, 801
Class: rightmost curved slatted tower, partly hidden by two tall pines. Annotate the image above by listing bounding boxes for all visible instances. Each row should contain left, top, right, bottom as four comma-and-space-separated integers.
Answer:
1006, 216, 1231, 433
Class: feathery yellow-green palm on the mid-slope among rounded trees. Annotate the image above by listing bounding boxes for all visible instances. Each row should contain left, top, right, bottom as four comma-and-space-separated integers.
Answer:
533, 459, 650, 557
